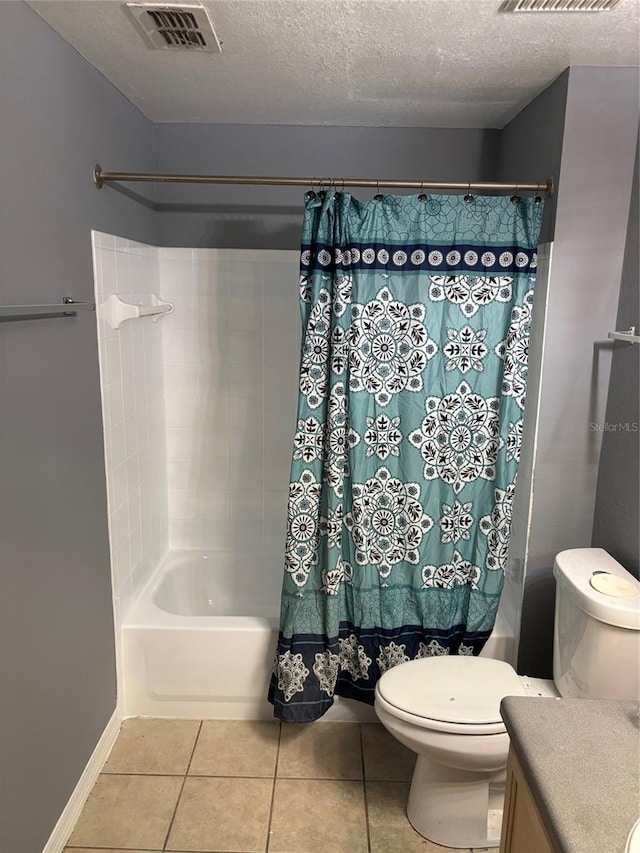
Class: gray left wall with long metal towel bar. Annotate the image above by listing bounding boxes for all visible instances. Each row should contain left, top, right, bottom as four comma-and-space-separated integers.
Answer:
0, 2, 156, 853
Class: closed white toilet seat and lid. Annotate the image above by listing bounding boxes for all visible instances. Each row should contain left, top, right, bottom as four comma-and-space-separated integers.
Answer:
376, 655, 527, 735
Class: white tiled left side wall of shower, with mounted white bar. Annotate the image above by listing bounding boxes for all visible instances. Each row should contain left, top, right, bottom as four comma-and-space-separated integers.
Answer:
92, 231, 169, 644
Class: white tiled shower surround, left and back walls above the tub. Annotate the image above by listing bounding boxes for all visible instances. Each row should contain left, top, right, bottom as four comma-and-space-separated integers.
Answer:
94, 246, 300, 564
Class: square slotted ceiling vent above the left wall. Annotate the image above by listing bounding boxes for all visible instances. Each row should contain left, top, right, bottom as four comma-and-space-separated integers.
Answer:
126, 3, 222, 53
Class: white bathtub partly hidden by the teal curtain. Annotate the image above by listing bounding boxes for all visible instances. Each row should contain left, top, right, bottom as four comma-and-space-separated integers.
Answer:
122, 550, 513, 722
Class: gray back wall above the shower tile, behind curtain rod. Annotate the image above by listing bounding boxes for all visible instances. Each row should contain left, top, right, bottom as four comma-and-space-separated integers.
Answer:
154, 124, 500, 249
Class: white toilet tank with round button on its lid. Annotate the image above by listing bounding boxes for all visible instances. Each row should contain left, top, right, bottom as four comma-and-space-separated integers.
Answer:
553, 548, 640, 700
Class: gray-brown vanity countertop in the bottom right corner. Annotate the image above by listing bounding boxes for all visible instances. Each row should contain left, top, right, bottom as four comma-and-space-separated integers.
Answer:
500, 696, 640, 853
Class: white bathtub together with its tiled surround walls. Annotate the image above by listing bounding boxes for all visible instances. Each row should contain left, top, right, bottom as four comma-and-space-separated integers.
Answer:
94, 234, 513, 720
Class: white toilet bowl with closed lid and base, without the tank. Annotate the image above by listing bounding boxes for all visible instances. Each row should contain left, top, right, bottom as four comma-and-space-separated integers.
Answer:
375, 656, 557, 847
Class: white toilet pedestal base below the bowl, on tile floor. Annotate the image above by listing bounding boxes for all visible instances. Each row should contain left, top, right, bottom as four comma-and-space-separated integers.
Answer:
407, 755, 506, 847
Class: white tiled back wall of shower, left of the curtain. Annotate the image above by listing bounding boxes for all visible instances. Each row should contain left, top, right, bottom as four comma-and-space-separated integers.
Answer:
158, 248, 300, 552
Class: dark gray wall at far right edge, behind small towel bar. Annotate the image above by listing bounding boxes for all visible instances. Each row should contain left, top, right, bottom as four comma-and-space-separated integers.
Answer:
592, 128, 640, 577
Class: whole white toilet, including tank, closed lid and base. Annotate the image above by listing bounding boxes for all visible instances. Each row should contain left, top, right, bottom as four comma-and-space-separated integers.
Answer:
375, 548, 640, 847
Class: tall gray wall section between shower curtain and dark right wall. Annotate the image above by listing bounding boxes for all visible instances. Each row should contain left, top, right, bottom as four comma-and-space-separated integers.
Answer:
502, 67, 638, 676
